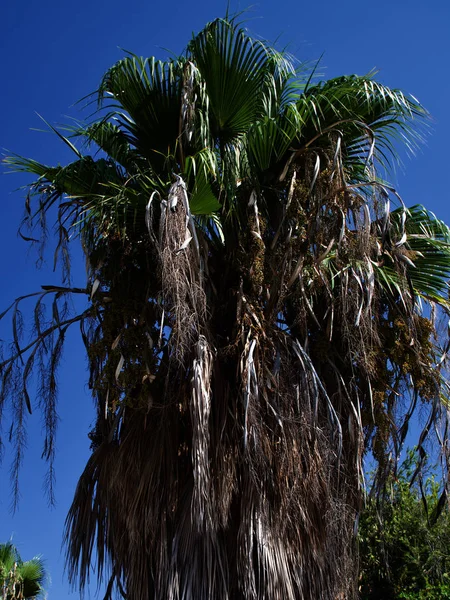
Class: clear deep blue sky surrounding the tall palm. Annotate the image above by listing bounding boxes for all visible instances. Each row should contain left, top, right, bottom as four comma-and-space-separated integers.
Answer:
0, 0, 450, 600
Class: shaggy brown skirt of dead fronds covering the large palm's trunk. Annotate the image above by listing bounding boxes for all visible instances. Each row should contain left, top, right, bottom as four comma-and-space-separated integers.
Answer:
68, 170, 372, 600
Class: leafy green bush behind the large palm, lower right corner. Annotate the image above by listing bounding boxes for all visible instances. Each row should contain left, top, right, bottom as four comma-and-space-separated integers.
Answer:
359, 452, 450, 600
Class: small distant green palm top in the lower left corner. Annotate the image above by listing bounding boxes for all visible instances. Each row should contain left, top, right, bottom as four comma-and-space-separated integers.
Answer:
0, 542, 46, 600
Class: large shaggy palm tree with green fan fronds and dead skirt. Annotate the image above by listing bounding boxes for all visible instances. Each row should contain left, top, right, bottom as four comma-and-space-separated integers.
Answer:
1, 19, 450, 600
